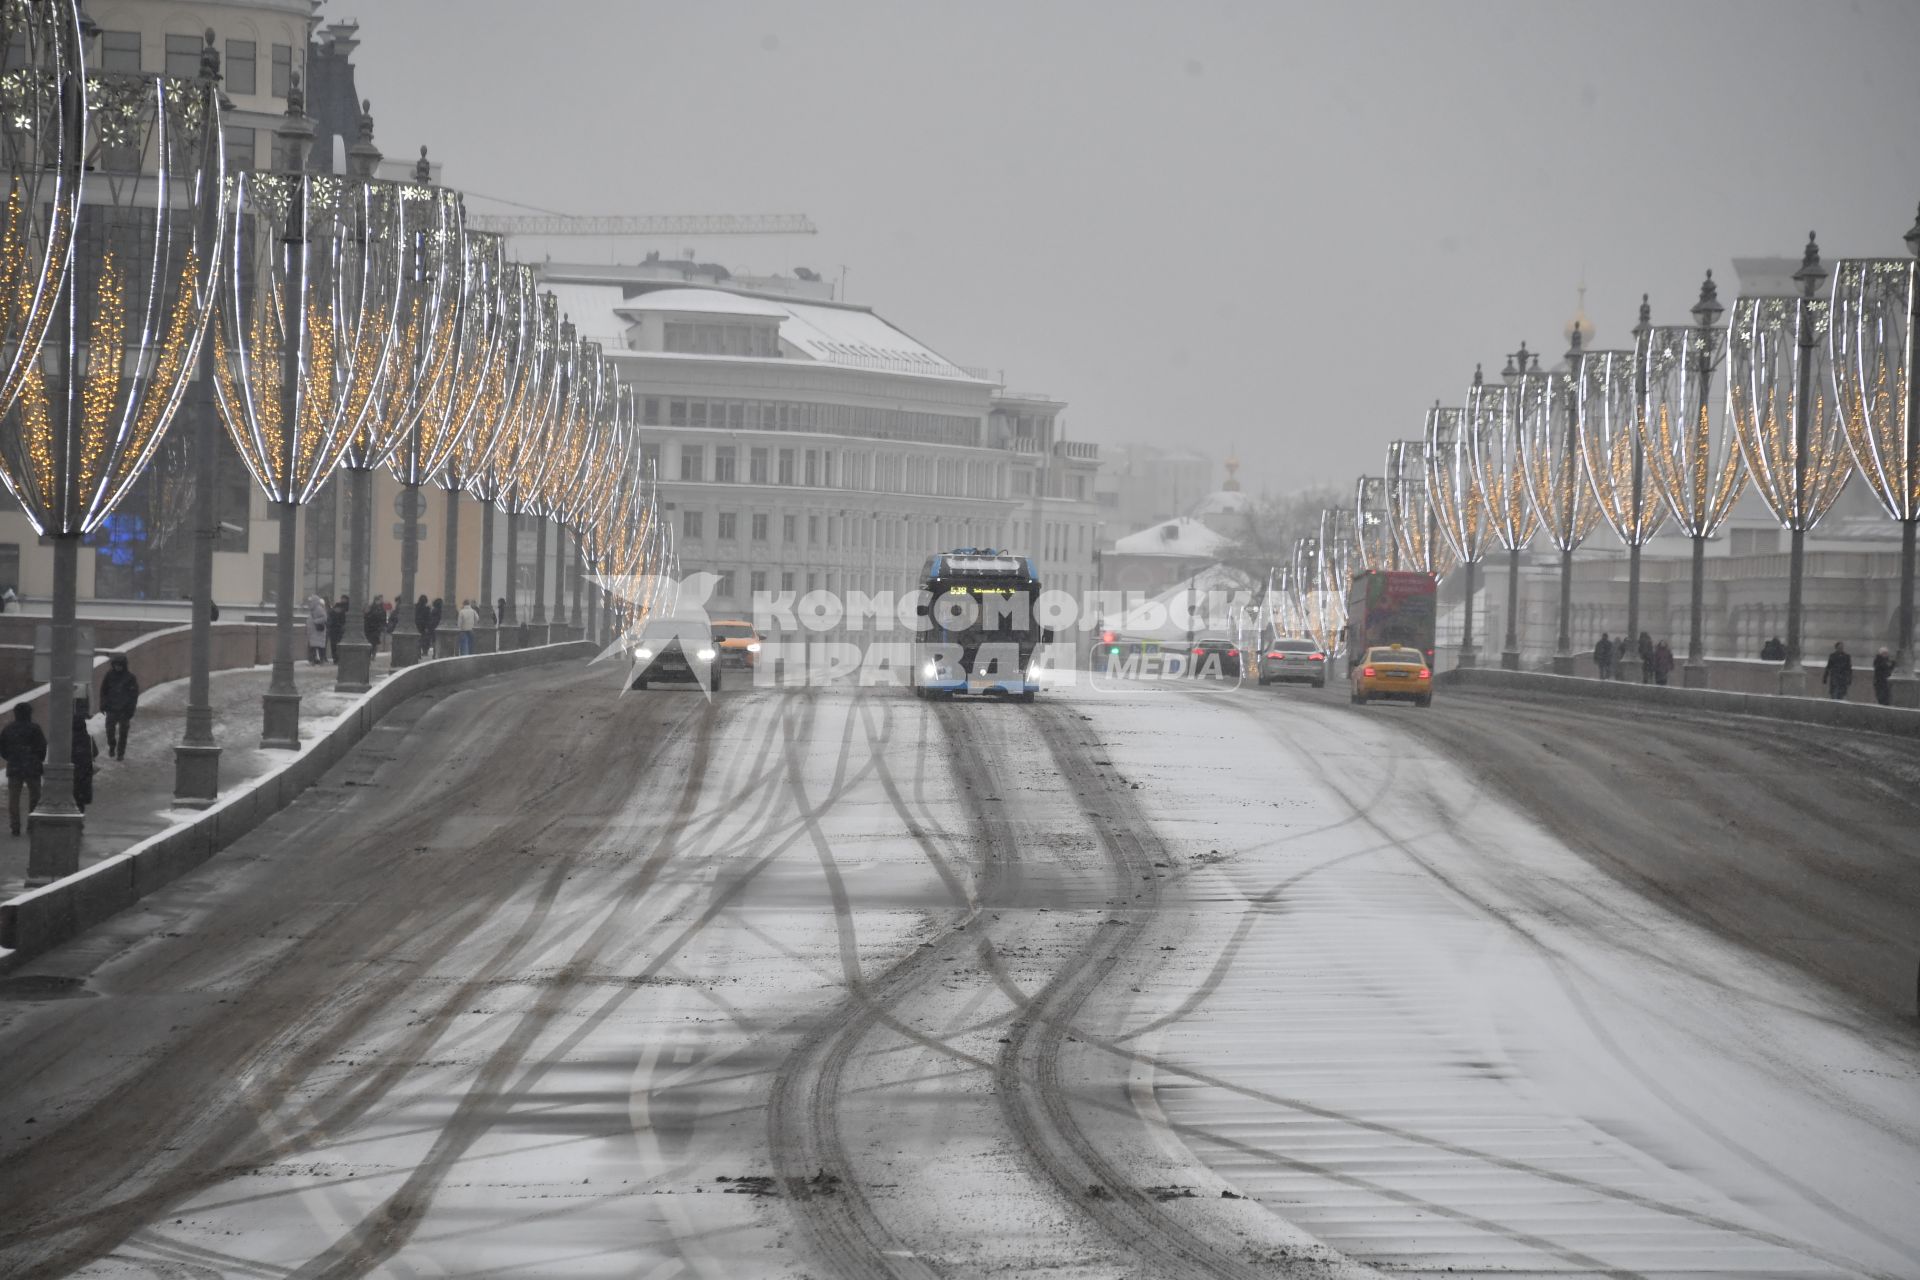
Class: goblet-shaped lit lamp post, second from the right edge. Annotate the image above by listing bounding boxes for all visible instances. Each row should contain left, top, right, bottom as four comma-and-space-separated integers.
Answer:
1726, 232, 1853, 697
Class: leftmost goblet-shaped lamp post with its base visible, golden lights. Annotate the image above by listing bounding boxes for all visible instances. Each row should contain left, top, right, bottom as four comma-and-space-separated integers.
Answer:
0, 55, 223, 885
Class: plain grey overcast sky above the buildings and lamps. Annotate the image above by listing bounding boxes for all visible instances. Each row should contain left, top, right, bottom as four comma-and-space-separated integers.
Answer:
349, 0, 1920, 491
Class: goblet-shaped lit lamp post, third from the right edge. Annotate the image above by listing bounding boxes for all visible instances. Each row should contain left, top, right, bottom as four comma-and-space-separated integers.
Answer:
1644, 271, 1747, 689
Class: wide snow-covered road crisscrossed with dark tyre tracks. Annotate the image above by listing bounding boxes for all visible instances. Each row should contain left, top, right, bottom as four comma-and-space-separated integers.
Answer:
0, 668, 1920, 1280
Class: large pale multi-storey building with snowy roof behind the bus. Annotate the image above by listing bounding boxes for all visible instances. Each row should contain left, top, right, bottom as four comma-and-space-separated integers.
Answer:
541, 263, 1100, 637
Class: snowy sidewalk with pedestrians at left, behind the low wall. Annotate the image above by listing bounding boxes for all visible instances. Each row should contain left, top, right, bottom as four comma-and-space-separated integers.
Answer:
0, 649, 408, 900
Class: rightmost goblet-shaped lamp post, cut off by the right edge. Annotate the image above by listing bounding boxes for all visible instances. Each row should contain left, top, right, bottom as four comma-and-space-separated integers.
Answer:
1828, 217, 1920, 706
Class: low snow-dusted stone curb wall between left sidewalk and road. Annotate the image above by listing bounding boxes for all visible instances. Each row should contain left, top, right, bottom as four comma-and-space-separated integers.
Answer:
0, 641, 599, 973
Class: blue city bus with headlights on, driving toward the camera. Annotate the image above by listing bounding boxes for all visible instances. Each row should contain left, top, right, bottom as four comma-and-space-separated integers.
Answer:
914, 547, 1054, 702
